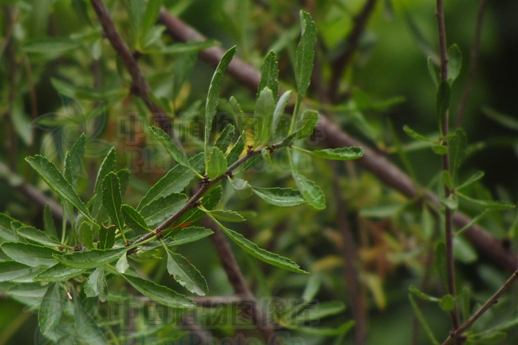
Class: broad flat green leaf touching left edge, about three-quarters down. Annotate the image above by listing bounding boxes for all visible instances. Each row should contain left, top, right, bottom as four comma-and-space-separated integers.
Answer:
1, 243, 61, 267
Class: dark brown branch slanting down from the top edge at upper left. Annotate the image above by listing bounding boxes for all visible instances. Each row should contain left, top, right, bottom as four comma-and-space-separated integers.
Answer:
90, 0, 183, 149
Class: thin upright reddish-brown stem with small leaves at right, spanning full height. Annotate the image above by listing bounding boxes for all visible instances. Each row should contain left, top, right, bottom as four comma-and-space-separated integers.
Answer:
435, 0, 462, 338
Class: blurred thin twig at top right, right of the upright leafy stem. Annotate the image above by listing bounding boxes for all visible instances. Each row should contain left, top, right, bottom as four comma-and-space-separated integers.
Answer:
455, 0, 487, 127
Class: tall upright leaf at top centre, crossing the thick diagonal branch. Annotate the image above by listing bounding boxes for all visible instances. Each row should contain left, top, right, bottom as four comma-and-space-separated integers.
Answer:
295, 11, 317, 98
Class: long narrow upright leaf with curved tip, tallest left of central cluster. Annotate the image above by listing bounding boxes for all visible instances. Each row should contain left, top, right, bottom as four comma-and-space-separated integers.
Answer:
204, 46, 240, 170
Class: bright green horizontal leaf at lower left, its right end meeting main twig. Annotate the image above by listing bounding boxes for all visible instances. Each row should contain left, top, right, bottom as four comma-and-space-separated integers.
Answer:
54, 247, 131, 269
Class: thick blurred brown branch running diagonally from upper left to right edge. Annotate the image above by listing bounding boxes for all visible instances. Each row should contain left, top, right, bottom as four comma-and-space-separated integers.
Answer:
159, 9, 518, 272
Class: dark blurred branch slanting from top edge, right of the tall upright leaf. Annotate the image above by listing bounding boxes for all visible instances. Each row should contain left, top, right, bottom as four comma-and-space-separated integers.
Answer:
328, 0, 376, 102
